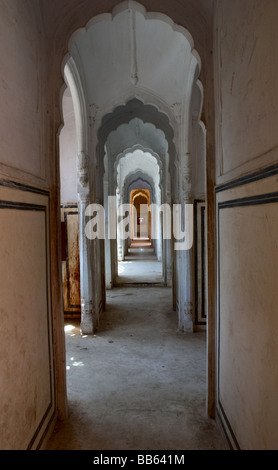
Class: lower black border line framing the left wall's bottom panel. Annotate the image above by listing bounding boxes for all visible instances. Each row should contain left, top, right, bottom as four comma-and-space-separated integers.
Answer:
0, 199, 56, 450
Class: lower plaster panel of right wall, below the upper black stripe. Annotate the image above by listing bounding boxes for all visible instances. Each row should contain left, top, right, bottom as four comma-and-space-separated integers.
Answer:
217, 177, 278, 450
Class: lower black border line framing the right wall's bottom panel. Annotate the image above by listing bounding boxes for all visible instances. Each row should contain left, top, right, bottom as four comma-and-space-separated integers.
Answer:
216, 192, 278, 450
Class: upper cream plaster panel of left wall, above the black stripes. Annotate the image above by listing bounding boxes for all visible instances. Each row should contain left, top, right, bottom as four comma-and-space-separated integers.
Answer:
0, 0, 47, 184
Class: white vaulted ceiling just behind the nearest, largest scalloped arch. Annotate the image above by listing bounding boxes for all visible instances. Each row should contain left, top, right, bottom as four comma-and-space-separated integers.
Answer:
69, 2, 198, 126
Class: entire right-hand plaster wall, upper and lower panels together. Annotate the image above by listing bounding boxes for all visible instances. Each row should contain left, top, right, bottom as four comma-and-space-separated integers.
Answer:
215, 0, 278, 450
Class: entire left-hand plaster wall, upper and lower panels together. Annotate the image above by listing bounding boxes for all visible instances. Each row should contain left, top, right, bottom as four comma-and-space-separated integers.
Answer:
0, 0, 57, 450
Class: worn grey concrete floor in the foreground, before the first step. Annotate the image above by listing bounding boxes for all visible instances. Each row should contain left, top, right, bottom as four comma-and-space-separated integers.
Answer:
47, 287, 226, 450
